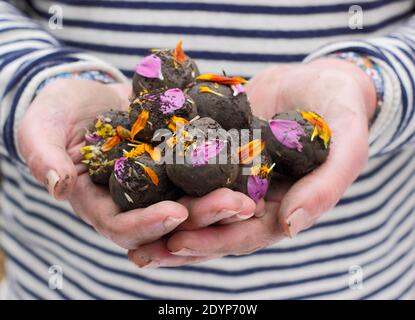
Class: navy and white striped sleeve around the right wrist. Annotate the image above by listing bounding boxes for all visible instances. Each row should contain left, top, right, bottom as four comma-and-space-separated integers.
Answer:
304, 16, 415, 157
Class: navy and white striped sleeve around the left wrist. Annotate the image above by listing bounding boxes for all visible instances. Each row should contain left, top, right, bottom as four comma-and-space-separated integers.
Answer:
0, 0, 127, 162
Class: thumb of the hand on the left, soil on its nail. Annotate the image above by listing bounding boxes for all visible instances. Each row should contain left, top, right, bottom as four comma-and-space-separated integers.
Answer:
18, 103, 77, 200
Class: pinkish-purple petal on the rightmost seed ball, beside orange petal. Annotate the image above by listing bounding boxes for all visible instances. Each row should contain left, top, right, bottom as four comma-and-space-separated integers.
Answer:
269, 119, 305, 152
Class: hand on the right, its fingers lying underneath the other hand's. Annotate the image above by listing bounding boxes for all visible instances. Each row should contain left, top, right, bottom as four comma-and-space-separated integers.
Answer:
129, 58, 376, 267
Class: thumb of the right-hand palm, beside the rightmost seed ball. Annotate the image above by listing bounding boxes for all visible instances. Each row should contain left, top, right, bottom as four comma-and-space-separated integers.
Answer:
279, 114, 368, 237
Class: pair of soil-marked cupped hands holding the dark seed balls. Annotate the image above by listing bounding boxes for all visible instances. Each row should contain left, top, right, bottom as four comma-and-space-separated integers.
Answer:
18, 58, 376, 268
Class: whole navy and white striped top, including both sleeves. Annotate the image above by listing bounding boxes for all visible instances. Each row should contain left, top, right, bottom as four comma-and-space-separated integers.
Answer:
0, 0, 415, 299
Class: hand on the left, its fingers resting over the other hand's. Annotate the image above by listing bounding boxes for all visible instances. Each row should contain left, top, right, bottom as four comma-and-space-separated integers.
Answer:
18, 79, 255, 249
